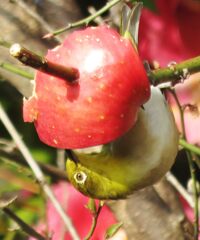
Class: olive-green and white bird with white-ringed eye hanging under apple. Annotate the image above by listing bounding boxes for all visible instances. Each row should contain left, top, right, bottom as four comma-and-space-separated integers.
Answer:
66, 86, 179, 200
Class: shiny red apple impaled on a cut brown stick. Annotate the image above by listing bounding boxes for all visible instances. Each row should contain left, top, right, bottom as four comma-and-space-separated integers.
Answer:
23, 25, 150, 149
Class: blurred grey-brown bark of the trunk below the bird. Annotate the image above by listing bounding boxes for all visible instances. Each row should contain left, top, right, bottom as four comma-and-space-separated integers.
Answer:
109, 181, 193, 240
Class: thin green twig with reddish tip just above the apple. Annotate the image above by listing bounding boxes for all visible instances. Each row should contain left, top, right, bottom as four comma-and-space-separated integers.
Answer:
44, 0, 122, 38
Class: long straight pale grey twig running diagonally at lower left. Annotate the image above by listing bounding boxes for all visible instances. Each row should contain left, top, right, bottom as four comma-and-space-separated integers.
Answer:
0, 105, 80, 240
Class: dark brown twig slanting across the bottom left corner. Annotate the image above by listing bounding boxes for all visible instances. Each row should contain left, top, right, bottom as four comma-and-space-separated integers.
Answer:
2, 207, 46, 240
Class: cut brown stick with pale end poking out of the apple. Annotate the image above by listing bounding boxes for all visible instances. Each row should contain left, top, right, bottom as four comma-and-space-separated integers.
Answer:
10, 43, 79, 83
